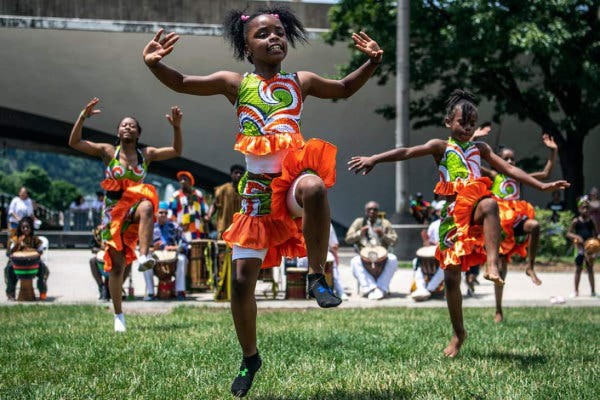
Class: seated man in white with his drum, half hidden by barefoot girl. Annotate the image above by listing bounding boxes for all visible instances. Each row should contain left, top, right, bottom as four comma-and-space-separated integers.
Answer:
410, 200, 446, 301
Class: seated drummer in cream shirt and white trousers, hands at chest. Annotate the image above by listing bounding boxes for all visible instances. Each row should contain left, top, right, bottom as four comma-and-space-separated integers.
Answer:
346, 201, 398, 300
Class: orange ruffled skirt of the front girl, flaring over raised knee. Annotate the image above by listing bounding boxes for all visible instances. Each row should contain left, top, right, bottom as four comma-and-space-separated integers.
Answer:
223, 139, 337, 268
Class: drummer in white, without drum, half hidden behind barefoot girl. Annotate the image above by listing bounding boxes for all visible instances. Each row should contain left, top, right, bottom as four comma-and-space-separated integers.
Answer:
410, 200, 446, 301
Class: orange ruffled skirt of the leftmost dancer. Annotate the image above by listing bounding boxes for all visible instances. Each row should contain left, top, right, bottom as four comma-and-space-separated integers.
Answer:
100, 179, 158, 272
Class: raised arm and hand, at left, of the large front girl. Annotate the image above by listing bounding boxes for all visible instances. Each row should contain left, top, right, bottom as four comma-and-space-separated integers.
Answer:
142, 29, 242, 104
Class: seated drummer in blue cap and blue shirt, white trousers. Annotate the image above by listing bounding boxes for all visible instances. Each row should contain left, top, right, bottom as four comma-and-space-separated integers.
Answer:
144, 201, 188, 301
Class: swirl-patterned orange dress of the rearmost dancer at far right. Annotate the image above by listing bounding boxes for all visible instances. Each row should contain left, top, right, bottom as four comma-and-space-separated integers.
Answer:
491, 173, 535, 261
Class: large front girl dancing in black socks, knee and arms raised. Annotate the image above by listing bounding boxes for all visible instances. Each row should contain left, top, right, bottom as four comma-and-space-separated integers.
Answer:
143, 6, 383, 397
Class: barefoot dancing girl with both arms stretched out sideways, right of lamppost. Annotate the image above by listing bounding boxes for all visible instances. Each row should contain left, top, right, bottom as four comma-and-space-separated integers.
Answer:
348, 90, 569, 357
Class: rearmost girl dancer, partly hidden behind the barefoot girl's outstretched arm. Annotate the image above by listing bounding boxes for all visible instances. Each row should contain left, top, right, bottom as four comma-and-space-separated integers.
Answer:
473, 128, 558, 322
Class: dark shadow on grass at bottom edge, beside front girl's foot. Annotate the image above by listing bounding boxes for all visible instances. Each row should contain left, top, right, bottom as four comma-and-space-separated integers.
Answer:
252, 389, 414, 400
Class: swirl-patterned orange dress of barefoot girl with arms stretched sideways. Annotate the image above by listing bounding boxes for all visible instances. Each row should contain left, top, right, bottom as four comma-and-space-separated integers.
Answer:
434, 138, 492, 271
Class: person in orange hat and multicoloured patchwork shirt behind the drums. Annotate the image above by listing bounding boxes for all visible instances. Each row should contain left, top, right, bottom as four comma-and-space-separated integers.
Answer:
169, 171, 208, 239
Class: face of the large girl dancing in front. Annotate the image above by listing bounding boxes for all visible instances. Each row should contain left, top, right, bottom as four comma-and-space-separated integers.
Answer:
246, 14, 287, 65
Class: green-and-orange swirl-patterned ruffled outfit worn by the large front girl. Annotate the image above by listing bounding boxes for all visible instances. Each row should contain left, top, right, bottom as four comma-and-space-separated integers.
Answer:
223, 71, 337, 268
